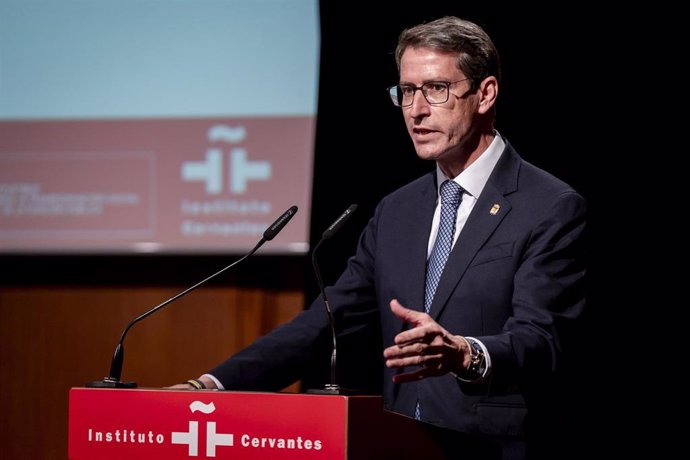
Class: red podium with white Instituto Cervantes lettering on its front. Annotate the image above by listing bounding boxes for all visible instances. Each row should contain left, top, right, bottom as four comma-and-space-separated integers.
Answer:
68, 388, 498, 460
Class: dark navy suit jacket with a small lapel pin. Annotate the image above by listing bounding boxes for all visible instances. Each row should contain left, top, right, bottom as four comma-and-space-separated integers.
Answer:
210, 140, 586, 450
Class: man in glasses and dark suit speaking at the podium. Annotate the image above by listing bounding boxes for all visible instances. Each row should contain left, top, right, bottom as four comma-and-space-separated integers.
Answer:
175, 17, 586, 458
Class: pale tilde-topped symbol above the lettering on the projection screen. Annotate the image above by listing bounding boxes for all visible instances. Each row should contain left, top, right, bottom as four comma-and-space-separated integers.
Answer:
181, 125, 271, 195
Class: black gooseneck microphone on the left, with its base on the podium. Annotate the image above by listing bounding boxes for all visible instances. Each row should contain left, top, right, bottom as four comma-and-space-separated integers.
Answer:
86, 206, 297, 388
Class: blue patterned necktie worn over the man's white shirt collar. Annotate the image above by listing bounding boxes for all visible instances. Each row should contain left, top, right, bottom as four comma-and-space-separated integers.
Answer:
414, 180, 462, 420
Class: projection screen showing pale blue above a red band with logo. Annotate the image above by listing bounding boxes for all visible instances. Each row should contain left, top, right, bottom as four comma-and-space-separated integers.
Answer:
0, 0, 320, 254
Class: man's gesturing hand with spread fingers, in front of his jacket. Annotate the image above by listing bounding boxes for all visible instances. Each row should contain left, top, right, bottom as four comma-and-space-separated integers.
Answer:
383, 299, 470, 383
